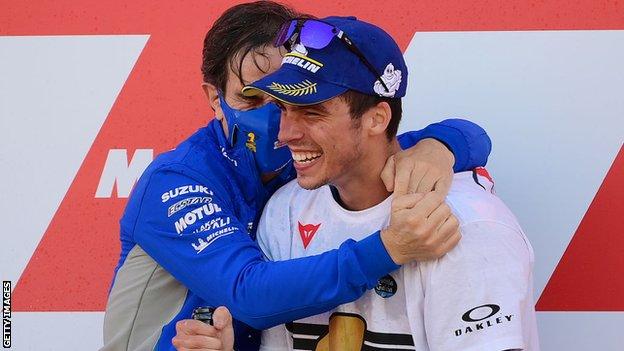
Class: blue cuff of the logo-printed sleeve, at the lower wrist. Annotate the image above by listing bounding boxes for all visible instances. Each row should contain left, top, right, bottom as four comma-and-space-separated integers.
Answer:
353, 231, 400, 289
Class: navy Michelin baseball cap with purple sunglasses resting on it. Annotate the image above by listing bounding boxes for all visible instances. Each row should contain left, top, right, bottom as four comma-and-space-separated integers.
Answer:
242, 17, 407, 105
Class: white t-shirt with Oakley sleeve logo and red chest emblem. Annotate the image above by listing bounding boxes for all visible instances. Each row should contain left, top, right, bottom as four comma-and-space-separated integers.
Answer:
257, 172, 539, 351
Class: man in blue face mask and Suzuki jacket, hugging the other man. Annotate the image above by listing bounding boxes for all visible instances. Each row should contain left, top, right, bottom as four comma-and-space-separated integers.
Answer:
103, 2, 489, 350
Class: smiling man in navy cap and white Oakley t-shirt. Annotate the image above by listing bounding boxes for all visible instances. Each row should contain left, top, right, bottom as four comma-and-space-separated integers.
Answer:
238, 17, 539, 351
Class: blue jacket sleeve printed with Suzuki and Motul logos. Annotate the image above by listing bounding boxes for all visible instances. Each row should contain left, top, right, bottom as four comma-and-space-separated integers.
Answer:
134, 166, 398, 329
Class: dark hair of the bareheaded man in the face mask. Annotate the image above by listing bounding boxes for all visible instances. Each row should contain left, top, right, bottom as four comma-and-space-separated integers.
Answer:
201, 1, 298, 92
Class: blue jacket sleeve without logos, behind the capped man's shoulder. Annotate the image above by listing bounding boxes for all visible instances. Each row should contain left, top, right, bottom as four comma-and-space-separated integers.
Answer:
398, 118, 492, 172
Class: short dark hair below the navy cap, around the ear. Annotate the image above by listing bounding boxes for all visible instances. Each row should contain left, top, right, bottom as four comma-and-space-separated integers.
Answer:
340, 90, 403, 140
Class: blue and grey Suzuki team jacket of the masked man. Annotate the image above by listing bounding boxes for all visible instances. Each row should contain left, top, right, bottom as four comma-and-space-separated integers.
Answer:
102, 119, 491, 350
